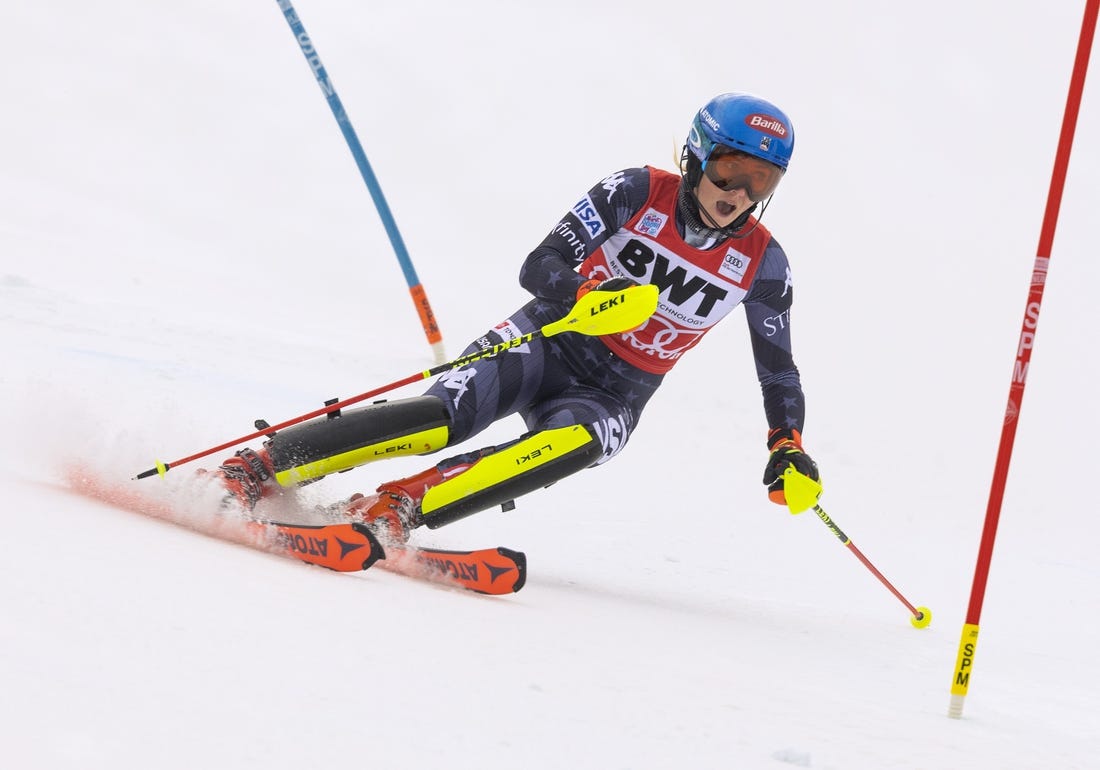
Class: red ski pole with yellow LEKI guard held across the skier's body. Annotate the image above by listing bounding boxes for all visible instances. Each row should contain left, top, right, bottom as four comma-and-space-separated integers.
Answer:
134, 284, 659, 480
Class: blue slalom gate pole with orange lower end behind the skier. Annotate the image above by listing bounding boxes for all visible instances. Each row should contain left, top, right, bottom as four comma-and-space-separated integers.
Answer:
276, 0, 446, 363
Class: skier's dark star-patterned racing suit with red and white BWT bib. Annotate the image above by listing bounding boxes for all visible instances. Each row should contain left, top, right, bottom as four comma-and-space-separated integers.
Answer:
426, 167, 805, 468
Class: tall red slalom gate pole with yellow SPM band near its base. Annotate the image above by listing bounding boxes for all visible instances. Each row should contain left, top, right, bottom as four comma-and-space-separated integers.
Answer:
947, 0, 1100, 719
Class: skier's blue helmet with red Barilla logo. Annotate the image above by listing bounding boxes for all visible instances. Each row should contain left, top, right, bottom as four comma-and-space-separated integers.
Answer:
688, 92, 794, 171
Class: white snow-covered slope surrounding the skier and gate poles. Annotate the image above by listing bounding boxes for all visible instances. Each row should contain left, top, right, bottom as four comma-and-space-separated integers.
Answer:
0, 0, 1100, 770
